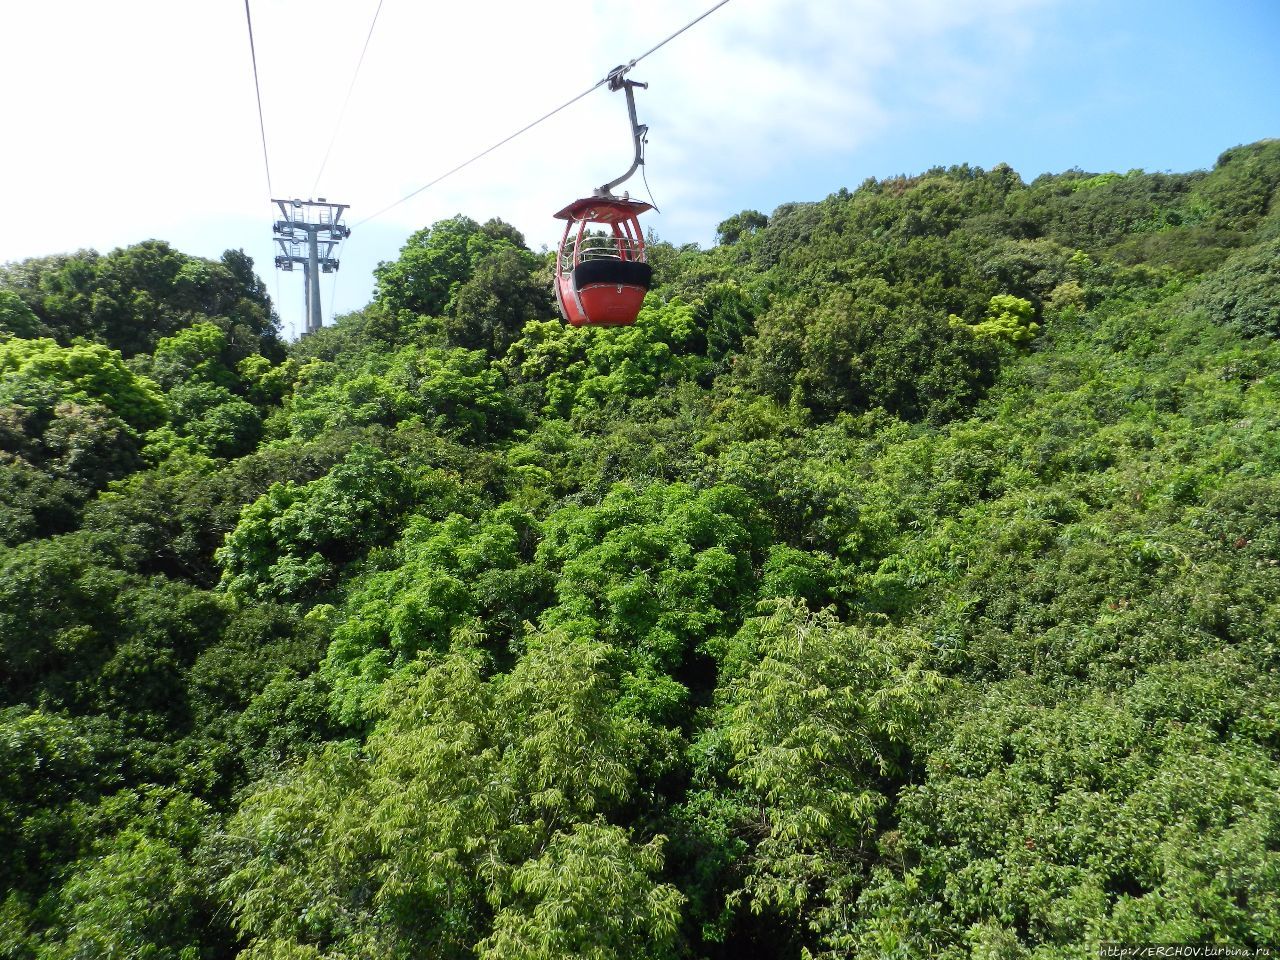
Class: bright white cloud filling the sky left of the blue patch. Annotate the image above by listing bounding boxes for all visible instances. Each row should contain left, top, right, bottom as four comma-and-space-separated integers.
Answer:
0, 0, 1046, 337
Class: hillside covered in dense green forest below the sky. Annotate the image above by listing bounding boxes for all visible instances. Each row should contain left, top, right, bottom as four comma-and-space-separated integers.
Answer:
0, 141, 1280, 960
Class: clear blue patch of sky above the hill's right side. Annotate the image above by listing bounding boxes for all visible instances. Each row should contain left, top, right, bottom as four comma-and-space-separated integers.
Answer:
721, 0, 1280, 212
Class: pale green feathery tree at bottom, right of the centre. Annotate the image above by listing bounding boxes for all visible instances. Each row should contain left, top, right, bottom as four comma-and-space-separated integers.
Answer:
701, 600, 942, 956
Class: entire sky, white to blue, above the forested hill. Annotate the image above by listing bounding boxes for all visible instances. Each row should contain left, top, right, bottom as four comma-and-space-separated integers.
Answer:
0, 0, 1280, 333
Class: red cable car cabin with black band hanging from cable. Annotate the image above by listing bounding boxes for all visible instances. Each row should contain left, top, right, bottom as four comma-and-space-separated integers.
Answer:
556, 197, 653, 326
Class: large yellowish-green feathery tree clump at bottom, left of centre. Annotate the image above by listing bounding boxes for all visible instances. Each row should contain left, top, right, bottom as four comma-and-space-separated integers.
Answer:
224, 632, 660, 959
